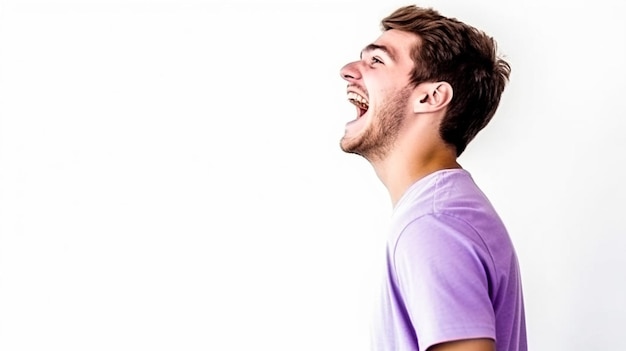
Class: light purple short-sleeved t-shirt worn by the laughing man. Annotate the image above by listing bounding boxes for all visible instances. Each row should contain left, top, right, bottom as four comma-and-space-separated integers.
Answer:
372, 169, 527, 351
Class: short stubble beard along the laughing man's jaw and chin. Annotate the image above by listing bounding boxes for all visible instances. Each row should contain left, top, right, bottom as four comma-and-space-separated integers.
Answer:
340, 87, 411, 162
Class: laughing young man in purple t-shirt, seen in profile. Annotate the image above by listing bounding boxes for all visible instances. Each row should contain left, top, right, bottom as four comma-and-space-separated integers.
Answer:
341, 6, 527, 351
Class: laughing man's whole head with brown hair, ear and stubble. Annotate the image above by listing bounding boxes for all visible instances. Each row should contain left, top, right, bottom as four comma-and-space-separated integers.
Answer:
341, 6, 510, 159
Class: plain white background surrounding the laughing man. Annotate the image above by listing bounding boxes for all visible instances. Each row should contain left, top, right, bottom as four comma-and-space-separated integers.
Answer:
0, 0, 626, 351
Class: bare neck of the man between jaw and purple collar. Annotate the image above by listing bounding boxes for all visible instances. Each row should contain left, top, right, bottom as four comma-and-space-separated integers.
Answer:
370, 141, 462, 207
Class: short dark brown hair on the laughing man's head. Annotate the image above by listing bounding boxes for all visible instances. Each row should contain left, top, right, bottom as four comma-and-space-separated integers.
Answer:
381, 5, 511, 156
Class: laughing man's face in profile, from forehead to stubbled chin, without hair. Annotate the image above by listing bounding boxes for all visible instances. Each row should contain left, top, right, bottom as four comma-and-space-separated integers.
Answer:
340, 29, 418, 159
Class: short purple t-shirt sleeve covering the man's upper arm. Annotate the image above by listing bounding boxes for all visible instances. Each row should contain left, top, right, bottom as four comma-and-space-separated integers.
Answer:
393, 214, 496, 350
